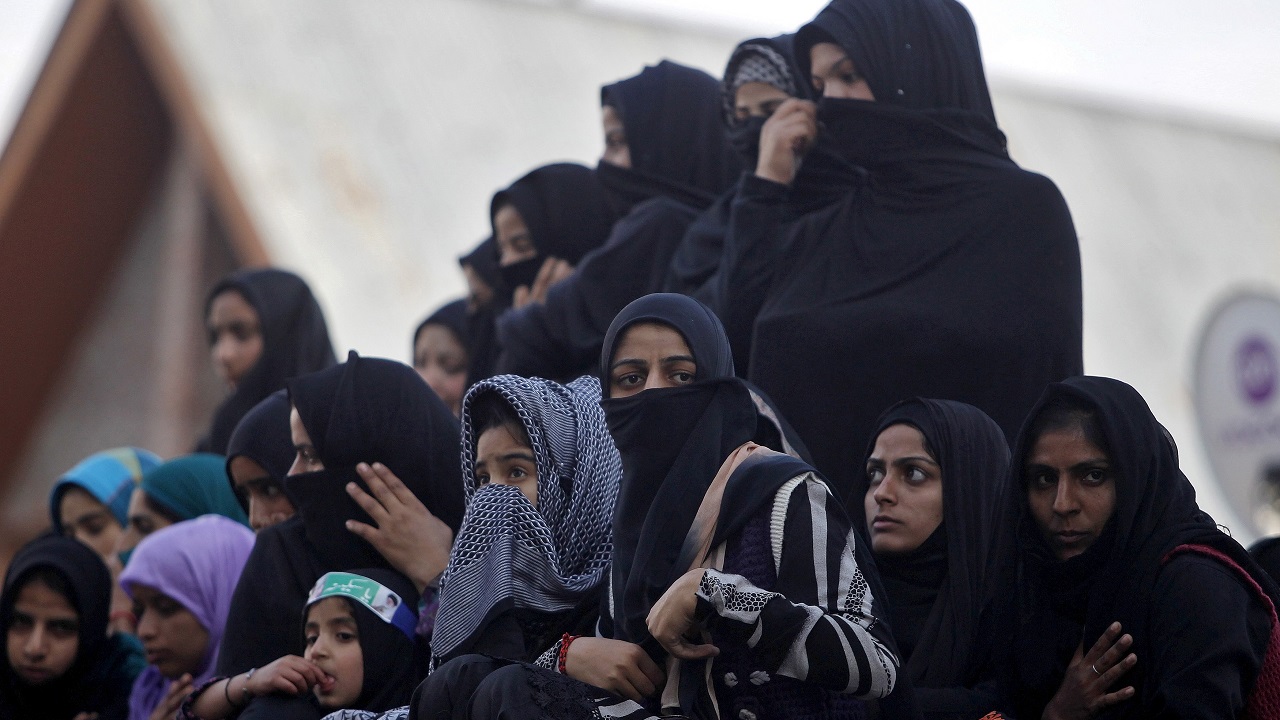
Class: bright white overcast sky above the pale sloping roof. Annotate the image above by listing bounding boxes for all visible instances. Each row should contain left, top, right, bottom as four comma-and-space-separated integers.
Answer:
0, 0, 1280, 147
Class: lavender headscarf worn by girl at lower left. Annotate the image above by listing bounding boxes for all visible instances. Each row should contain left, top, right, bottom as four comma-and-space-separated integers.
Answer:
120, 515, 253, 720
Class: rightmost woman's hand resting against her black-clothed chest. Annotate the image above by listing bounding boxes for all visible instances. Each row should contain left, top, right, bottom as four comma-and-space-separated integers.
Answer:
1042, 623, 1138, 720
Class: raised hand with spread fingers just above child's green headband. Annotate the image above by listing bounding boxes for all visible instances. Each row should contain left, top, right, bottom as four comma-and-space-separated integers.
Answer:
347, 462, 453, 594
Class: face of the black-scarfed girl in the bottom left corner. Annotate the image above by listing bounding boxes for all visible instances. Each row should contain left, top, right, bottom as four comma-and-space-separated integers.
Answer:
5, 579, 79, 685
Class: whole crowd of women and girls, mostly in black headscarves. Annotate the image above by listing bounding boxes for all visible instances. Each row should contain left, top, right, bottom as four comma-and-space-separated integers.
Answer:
0, 0, 1280, 720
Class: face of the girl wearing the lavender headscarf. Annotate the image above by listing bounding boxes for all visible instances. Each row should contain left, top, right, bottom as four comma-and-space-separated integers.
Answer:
133, 584, 209, 680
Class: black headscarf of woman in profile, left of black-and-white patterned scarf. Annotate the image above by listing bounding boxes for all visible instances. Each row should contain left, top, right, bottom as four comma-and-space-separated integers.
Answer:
596, 60, 739, 209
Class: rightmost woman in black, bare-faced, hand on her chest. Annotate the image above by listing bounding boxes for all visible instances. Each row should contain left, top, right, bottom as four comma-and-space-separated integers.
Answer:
1001, 377, 1280, 719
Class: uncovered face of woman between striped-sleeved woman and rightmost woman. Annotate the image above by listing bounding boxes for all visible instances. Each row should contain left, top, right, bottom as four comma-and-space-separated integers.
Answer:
863, 424, 942, 555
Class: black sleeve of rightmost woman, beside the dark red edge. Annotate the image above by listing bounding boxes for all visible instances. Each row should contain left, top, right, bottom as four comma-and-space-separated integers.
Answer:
1141, 556, 1271, 720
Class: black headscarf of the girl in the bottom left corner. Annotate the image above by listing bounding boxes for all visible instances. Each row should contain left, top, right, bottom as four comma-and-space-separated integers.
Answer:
0, 536, 145, 720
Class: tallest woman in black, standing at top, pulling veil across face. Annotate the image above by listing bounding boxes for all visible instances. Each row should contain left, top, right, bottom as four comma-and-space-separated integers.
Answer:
742, 0, 1082, 514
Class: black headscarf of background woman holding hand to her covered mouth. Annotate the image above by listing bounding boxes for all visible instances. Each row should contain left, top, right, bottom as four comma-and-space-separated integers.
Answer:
489, 163, 618, 301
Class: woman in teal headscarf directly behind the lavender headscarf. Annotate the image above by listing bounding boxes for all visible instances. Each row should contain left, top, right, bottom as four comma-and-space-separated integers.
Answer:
115, 452, 248, 565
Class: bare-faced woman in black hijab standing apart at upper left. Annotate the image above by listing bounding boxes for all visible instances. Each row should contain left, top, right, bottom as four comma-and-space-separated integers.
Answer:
197, 268, 337, 455
